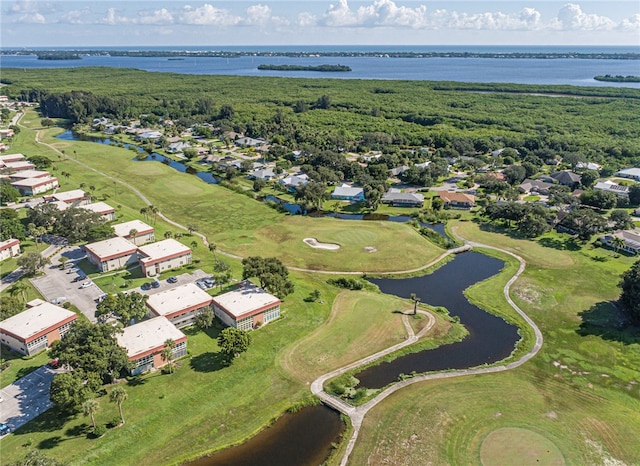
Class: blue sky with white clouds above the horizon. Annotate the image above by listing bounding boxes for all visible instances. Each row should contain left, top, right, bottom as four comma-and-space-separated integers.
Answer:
0, 0, 640, 48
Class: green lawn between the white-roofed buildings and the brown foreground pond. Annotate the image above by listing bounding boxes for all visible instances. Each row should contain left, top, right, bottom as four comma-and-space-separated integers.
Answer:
0, 275, 336, 465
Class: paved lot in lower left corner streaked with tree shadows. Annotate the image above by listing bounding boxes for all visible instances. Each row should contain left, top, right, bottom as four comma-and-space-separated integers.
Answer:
0, 366, 64, 432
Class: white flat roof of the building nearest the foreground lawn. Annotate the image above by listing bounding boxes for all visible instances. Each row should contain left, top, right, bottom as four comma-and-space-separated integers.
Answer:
116, 316, 186, 359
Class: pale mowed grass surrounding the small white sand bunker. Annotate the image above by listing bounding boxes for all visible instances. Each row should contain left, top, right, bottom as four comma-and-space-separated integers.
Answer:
234, 216, 444, 273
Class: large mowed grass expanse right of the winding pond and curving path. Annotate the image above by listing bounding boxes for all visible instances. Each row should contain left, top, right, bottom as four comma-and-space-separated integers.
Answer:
350, 222, 640, 465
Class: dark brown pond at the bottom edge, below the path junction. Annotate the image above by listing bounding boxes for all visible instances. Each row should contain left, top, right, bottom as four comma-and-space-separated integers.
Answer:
188, 405, 345, 466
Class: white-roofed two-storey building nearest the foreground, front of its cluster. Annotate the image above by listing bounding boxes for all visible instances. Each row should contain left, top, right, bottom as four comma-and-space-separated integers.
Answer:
116, 316, 187, 375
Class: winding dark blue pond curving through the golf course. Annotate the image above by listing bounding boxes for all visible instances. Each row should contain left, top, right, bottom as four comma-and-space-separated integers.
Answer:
355, 252, 520, 388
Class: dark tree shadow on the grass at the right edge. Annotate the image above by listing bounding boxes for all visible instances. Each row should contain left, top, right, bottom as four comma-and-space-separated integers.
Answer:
576, 301, 640, 345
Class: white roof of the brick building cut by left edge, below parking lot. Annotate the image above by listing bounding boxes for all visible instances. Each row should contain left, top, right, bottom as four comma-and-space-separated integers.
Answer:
0, 302, 78, 340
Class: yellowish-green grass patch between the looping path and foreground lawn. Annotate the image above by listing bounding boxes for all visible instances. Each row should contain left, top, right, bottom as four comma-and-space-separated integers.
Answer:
280, 291, 451, 383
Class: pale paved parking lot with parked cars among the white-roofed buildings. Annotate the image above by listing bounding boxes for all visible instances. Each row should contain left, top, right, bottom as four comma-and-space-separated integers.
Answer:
31, 246, 103, 322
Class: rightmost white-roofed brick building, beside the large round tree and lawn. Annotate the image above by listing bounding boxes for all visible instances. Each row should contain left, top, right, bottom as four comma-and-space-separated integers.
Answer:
213, 282, 280, 330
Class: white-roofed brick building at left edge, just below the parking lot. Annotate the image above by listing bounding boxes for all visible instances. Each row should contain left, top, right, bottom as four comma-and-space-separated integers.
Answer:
0, 301, 78, 356
